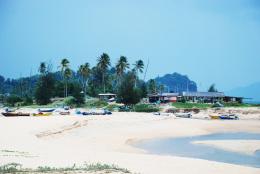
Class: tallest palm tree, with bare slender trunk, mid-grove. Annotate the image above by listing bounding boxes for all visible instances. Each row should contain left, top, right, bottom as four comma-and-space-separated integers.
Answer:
97, 53, 110, 93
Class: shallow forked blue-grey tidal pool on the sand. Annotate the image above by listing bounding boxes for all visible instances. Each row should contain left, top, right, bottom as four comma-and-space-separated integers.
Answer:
135, 132, 260, 168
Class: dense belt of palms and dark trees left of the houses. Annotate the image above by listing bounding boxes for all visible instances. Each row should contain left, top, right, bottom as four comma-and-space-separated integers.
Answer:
0, 53, 147, 107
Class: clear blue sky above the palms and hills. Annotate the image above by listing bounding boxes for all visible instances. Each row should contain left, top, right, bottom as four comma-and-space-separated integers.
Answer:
0, 0, 260, 91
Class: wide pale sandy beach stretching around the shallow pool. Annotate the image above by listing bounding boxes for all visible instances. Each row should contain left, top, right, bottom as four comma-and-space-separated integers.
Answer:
0, 108, 260, 174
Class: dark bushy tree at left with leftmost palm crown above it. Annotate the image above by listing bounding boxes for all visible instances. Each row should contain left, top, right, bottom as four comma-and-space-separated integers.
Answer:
35, 63, 55, 105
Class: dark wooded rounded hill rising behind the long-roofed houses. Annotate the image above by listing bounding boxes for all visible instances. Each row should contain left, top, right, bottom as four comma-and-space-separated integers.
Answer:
155, 72, 197, 92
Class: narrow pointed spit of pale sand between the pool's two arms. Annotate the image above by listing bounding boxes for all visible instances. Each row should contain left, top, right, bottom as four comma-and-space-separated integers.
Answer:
192, 140, 260, 155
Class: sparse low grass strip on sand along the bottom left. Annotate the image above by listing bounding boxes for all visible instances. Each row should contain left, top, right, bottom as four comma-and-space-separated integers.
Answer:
0, 163, 131, 174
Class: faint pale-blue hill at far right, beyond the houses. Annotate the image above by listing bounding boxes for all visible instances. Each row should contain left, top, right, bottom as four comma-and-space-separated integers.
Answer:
226, 82, 260, 101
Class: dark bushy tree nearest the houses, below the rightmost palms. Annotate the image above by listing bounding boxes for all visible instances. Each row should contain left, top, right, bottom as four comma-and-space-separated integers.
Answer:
118, 71, 141, 105
